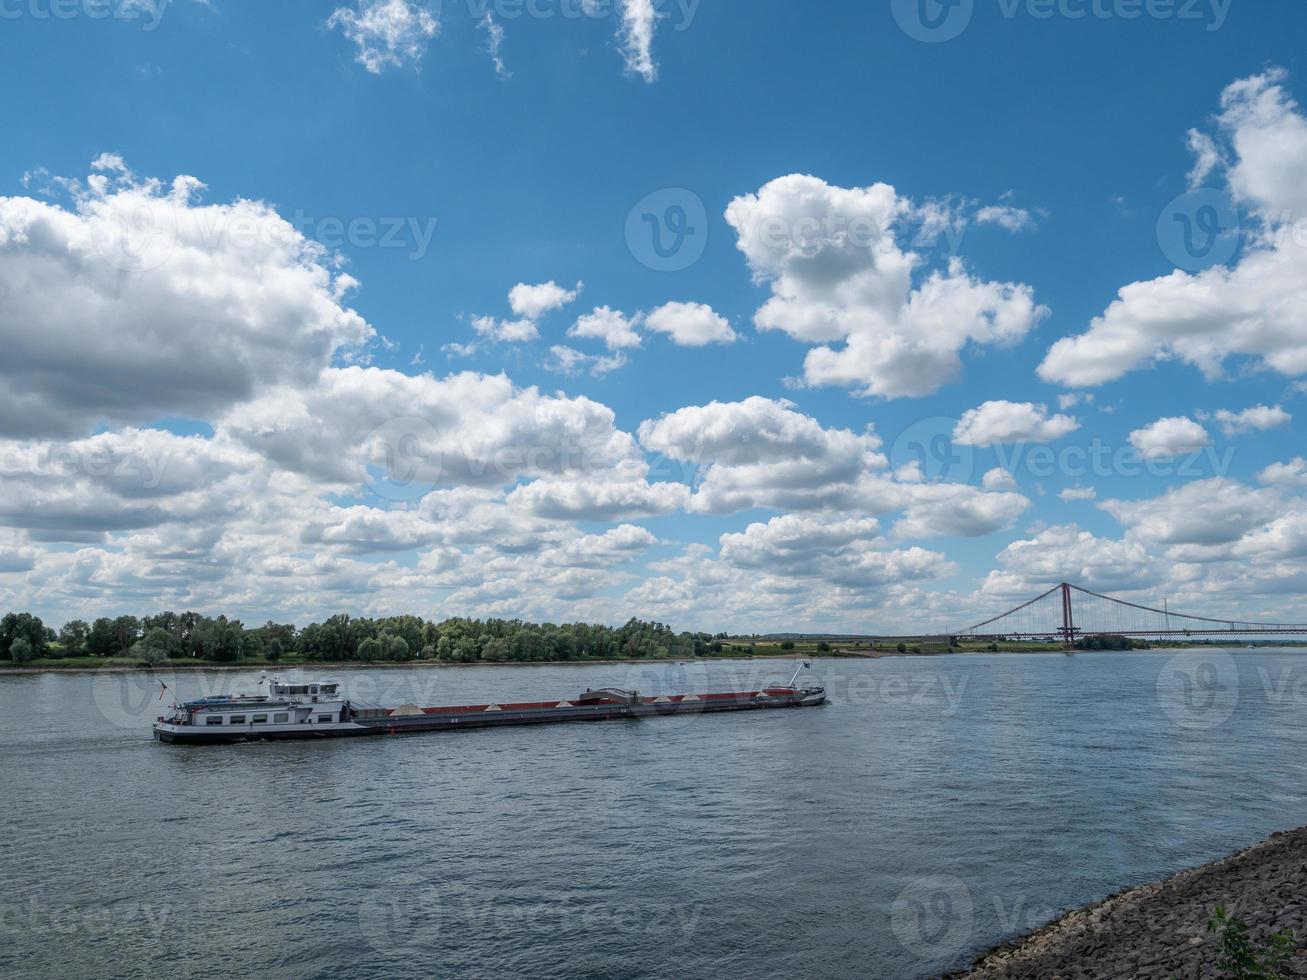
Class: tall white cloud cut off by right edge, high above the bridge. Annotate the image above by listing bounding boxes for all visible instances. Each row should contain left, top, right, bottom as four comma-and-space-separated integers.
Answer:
1039, 71, 1307, 387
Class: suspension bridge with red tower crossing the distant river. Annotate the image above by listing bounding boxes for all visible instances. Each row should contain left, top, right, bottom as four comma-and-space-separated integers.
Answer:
953, 581, 1307, 649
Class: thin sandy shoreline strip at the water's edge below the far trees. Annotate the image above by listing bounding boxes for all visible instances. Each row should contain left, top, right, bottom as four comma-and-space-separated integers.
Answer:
0, 647, 1294, 677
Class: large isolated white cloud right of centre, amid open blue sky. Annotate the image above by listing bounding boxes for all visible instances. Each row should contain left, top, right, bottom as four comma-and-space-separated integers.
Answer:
725, 174, 1047, 397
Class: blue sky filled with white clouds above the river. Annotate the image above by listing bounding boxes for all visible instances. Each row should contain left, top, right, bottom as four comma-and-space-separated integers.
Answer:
0, 0, 1307, 630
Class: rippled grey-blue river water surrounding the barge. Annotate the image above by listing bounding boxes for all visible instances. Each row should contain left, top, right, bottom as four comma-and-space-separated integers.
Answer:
0, 652, 1307, 980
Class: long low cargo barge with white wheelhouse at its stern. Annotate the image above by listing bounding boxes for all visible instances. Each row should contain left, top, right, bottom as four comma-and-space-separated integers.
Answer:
153, 668, 826, 745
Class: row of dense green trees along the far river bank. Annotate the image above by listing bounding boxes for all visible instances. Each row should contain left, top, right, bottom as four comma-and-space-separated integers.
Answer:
0, 613, 725, 664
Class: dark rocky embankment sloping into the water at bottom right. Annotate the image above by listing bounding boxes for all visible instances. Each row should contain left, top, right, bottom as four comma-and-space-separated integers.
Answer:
951, 827, 1307, 980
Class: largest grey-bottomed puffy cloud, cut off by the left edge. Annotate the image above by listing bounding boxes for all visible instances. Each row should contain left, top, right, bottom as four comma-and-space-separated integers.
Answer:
0, 155, 374, 435
